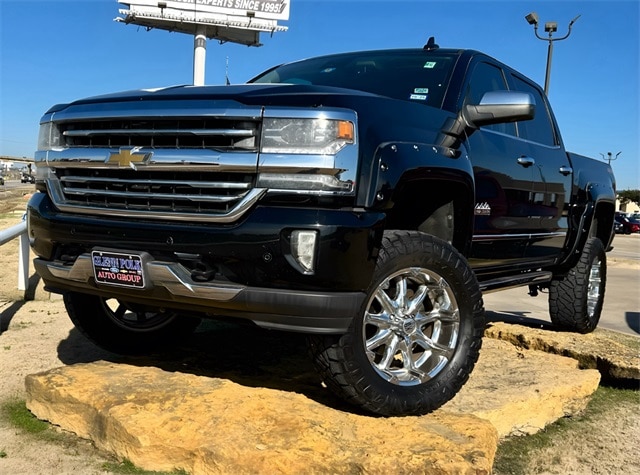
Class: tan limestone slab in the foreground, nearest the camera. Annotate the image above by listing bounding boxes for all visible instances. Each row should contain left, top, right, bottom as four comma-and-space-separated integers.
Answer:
26, 362, 498, 475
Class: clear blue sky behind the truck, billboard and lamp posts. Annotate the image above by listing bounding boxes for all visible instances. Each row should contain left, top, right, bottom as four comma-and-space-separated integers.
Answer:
0, 0, 640, 189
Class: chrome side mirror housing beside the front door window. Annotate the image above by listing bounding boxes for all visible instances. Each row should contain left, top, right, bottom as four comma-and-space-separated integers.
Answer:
461, 91, 536, 128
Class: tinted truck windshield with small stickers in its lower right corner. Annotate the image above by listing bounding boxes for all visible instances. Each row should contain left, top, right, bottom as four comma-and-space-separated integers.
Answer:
249, 50, 456, 107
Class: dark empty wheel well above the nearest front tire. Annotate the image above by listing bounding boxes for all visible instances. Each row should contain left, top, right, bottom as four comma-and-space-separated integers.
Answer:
386, 180, 472, 253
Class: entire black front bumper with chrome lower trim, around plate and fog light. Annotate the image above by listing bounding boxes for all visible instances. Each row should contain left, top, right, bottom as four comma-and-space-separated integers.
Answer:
28, 193, 384, 333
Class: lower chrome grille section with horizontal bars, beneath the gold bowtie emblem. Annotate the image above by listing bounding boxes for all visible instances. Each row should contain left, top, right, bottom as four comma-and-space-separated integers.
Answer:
48, 168, 264, 222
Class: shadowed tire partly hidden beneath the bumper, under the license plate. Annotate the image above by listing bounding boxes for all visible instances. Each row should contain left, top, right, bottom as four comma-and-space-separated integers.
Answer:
64, 292, 200, 355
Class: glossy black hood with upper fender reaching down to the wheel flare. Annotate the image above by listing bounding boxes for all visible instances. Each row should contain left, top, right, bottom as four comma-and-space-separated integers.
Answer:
43, 84, 455, 154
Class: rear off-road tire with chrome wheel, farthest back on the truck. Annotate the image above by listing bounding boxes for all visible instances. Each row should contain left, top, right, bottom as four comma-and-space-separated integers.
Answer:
549, 237, 607, 333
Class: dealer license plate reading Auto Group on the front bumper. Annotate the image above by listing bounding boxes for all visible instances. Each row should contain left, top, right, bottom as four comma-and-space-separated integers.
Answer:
91, 251, 144, 289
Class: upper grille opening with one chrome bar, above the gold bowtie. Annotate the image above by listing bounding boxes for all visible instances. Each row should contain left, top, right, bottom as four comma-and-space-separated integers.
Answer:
58, 117, 259, 151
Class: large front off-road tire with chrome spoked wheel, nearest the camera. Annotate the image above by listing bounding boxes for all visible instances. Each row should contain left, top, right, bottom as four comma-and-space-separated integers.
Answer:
308, 231, 484, 416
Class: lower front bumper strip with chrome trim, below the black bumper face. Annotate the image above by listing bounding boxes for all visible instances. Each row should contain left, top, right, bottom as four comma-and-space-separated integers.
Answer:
34, 254, 365, 333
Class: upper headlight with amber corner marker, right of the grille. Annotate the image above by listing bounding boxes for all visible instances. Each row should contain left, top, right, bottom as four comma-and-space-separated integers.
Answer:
261, 118, 354, 155
